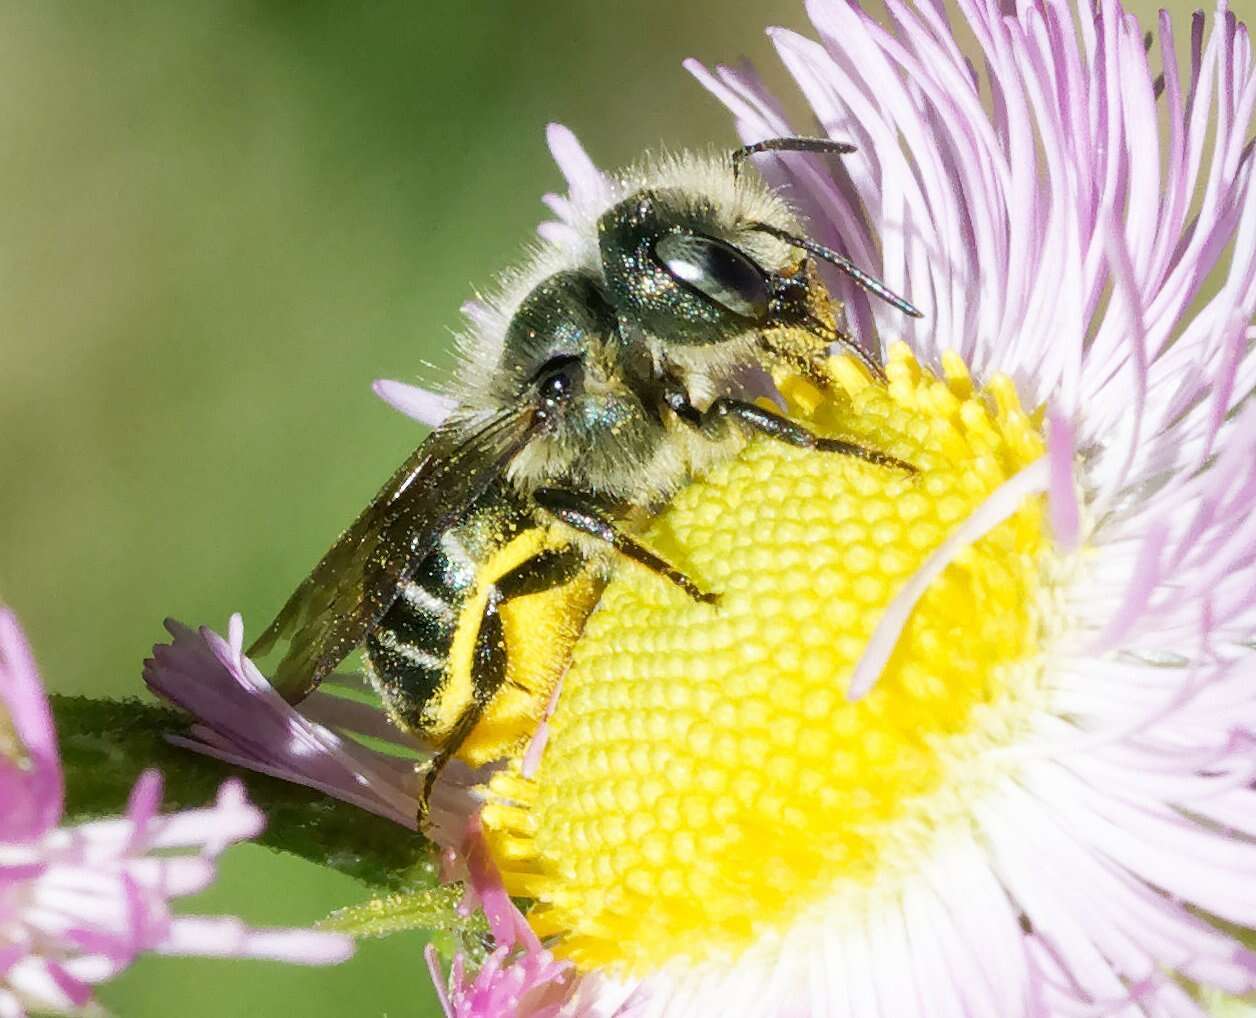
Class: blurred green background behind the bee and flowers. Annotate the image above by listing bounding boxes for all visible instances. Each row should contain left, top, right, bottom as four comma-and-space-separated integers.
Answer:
0, 0, 1186, 1018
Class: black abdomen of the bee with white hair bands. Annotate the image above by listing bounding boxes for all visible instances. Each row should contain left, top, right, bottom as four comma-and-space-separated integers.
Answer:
365, 549, 467, 744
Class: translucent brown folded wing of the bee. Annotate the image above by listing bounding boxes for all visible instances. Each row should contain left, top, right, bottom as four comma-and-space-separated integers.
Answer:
249, 408, 533, 703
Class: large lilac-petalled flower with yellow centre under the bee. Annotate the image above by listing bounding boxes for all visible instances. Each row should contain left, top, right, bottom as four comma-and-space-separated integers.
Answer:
472, 0, 1256, 1018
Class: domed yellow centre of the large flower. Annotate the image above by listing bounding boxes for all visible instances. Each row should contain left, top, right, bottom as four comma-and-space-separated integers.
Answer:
484, 345, 1050, 975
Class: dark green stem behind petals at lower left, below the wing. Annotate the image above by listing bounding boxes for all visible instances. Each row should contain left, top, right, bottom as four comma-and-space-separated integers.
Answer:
51, 694, 436, 891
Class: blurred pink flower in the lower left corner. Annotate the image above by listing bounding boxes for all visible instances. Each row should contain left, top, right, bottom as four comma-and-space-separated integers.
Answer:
0, 608, 352, 1015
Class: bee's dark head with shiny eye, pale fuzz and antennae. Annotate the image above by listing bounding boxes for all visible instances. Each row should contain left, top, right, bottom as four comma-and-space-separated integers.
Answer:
598, 155, 921, 374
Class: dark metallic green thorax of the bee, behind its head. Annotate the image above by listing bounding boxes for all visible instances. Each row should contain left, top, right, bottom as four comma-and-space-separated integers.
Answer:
494, 271, 662, 497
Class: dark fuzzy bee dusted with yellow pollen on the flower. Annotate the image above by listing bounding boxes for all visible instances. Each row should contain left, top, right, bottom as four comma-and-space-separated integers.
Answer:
249, 138, 921, 820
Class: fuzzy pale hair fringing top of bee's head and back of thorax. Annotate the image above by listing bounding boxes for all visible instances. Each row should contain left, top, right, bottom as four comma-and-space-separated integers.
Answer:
441, 151, 801, 412
